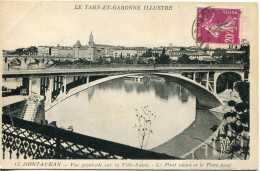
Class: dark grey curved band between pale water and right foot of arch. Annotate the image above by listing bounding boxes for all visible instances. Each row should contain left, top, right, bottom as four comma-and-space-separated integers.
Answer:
151, 109, 221, 158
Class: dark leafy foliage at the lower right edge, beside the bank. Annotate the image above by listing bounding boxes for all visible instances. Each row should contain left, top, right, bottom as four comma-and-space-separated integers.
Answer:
211, 82, 250, 160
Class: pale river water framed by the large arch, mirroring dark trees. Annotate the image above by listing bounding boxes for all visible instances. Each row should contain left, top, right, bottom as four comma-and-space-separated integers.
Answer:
46, 78, 196, 149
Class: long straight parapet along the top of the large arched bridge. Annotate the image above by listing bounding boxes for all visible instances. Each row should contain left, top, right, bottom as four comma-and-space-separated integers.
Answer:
3, 64, 244, 77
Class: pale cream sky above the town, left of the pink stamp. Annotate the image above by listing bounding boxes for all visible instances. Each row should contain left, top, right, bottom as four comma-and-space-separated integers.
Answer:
0, 1, 251, 50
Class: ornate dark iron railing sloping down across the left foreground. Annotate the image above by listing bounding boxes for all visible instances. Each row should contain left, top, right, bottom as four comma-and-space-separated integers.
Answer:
2, 114, 178, 159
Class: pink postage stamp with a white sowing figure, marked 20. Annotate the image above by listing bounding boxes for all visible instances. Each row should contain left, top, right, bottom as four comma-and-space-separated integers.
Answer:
196, 8, 241, 44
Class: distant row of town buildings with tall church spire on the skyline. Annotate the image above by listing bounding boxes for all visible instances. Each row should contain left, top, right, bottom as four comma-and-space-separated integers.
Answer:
38, 32, 249, 62
